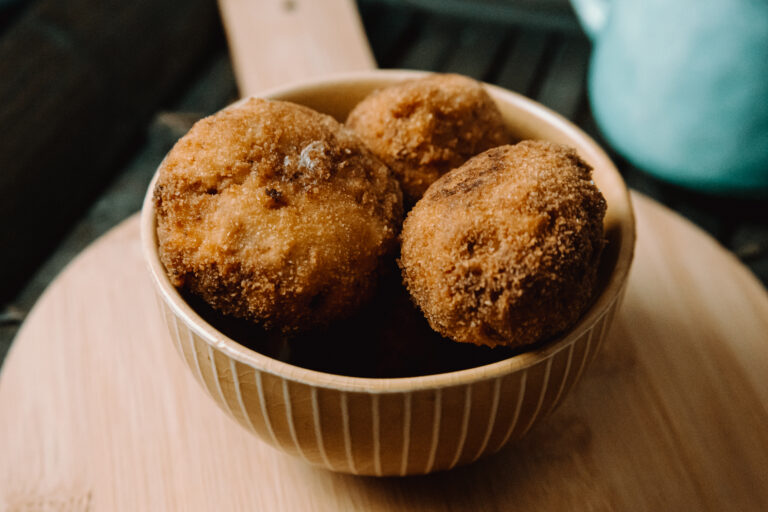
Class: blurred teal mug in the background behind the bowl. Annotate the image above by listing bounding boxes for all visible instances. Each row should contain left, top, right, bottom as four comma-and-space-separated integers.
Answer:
572, 0, 768, 197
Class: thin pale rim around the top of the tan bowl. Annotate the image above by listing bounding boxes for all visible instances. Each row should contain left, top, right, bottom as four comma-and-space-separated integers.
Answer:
141, 70, 635, 394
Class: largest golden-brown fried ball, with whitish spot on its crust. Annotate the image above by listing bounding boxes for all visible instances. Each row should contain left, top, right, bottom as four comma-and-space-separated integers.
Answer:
154, 99, 403, 332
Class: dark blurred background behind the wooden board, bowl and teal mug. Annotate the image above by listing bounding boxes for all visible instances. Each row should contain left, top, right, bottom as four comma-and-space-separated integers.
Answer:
0, 0, 768, 361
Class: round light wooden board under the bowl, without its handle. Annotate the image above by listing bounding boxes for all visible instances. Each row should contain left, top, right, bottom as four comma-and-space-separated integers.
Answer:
0, 194, 768, 511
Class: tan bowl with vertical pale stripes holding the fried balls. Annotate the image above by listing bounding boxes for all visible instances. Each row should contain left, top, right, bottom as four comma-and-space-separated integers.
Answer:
141, 71, 635, 476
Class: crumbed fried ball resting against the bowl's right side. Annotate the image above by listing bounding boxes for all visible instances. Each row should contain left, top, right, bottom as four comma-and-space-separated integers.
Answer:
400, 141, 606, 347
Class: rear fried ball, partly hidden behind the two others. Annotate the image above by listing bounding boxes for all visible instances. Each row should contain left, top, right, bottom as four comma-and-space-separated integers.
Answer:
347, 74, 511, 204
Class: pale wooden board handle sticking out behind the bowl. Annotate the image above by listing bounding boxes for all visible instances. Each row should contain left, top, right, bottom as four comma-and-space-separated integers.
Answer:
219, 0, 376, 96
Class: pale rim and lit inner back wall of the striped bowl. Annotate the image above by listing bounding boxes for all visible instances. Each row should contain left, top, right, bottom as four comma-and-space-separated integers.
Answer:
142, 71, 635, 392
